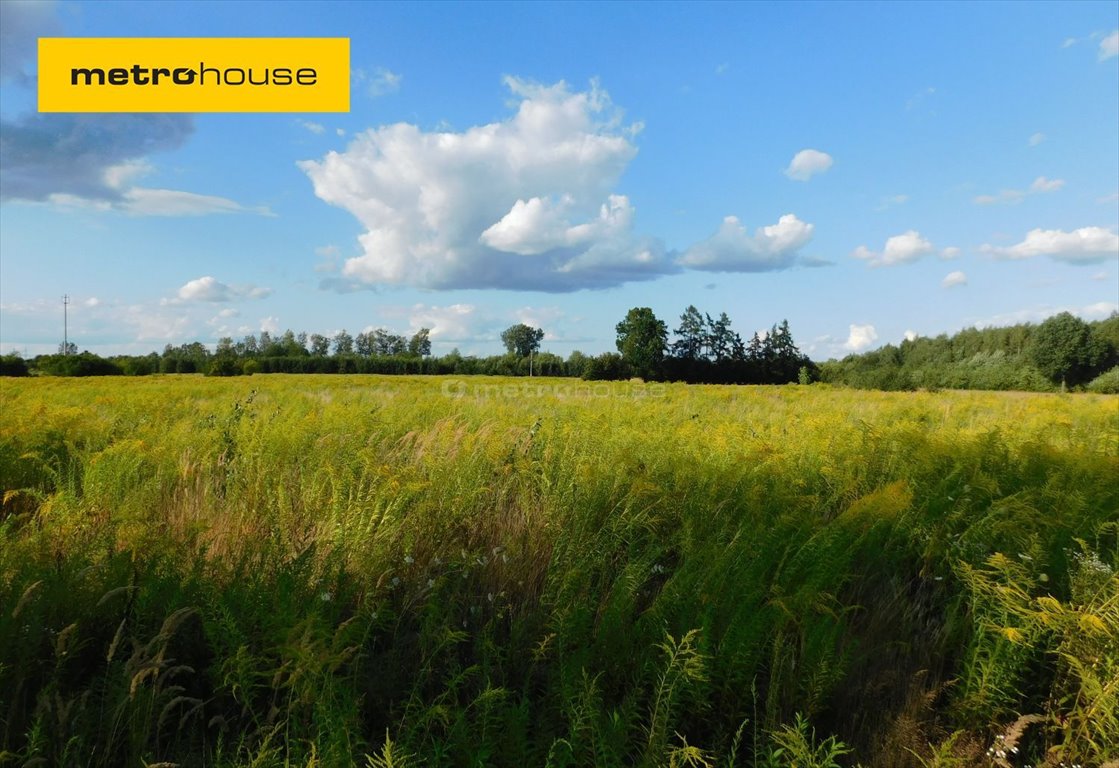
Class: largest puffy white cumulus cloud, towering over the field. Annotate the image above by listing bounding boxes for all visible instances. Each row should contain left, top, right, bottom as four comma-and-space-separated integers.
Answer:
299, 77, 678, 291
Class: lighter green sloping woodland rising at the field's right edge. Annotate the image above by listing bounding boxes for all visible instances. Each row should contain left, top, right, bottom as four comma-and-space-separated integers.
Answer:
819, 312, 1119, 393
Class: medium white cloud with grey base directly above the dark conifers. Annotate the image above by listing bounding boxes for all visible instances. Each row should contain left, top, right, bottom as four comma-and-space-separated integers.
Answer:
678, 214, 815, 272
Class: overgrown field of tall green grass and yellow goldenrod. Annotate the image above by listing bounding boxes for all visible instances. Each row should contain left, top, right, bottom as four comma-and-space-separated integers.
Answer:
0, 376, 1119, 768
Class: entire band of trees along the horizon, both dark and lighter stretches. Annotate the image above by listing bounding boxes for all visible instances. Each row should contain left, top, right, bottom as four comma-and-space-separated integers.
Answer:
0, 307, 1119, 393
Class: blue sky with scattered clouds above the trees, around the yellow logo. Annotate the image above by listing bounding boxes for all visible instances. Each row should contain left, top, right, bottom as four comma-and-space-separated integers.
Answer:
0, 0, 1119, 359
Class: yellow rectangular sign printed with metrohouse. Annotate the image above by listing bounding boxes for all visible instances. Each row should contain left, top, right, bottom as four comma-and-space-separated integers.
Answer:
39, 37, 350, 112
